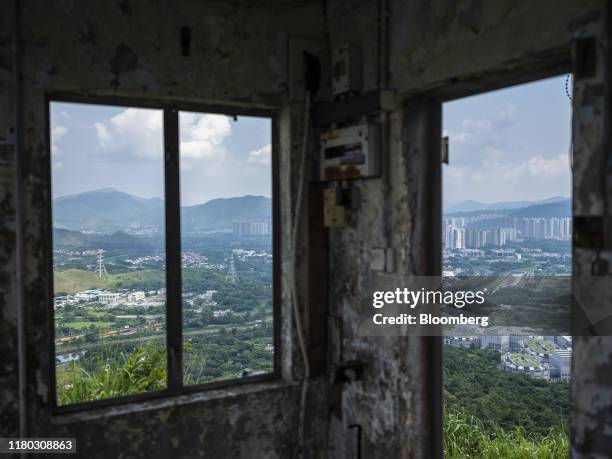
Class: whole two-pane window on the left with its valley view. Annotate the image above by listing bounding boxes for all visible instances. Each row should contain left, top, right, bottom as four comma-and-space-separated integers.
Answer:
49, 101, 277, 406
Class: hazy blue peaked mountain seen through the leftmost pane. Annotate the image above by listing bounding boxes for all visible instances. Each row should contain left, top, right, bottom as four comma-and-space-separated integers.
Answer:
53, 188, 164, 232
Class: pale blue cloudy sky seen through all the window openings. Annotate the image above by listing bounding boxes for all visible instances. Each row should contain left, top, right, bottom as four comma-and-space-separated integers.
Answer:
50, 76, 571, 207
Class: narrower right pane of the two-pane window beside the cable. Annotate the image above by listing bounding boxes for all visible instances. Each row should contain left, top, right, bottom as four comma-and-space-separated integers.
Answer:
179, 112, 274, 385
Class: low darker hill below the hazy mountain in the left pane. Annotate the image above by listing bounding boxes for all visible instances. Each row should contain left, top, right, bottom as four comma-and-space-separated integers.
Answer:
53, 228, 152, 250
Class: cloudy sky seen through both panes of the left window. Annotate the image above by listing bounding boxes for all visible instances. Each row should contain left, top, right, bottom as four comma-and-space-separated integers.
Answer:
50, 102, 272, 205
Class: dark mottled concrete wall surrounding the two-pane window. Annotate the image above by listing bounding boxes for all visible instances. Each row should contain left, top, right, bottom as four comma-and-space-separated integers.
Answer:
0, 0, 324, 458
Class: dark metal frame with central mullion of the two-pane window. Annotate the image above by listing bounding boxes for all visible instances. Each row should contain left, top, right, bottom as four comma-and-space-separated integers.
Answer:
44, 92, 282, 414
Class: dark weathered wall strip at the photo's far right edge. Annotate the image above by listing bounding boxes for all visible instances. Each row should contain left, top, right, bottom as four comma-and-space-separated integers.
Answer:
571, 3, 612, 458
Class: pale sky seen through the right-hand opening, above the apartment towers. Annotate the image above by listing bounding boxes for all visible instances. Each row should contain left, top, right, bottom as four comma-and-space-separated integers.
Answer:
443, 76, 571, 207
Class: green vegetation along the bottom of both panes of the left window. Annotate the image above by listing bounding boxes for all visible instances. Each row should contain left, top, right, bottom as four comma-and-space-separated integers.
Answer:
57, 323, 273, 405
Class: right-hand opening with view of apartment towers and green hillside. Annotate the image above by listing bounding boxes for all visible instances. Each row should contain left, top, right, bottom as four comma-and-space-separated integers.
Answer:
442, 77, 572, 457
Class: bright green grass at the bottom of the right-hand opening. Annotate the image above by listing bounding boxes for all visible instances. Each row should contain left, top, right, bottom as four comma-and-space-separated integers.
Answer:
444, 410, 569, 459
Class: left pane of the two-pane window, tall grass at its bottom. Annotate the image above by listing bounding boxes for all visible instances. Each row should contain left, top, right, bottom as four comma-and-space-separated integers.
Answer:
50, 102, 166, 405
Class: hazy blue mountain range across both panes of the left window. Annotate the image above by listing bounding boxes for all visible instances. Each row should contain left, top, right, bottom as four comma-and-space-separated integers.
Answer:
53, 188, 272, 233
